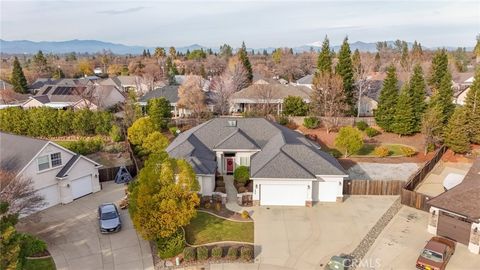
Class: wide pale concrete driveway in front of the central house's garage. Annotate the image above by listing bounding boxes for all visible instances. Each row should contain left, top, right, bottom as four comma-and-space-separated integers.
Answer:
252, 196, 397, 269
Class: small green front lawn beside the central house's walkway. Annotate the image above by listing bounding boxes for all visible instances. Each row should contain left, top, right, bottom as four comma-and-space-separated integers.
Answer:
185, 212, 253, 245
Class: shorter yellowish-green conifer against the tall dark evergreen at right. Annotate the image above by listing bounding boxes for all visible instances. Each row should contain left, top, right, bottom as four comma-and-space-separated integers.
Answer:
430, 71, 455, 124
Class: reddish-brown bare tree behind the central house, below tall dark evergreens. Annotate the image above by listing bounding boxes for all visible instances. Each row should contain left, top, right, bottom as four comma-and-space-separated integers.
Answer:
311, 73, 346, 132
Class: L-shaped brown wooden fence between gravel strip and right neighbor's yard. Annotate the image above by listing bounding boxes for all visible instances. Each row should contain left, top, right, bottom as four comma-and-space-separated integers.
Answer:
401, 145, 447, 212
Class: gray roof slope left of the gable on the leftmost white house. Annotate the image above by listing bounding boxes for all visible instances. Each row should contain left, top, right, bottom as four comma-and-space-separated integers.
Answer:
0, 132, 48, 172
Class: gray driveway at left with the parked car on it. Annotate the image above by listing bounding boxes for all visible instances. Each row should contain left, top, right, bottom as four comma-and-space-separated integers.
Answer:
17, 182, 153, 270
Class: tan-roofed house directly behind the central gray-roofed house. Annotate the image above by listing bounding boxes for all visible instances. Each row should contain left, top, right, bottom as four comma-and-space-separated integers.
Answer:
232, 84, 312, 114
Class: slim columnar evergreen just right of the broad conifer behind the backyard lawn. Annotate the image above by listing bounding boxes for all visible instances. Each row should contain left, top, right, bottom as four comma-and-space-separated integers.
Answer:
410, 64, 426, 132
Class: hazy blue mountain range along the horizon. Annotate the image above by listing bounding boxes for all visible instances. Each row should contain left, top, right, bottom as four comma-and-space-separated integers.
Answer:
0, 39, 472, 54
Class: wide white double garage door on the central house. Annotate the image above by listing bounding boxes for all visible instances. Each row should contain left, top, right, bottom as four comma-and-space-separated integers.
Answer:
260, 184, 307, 206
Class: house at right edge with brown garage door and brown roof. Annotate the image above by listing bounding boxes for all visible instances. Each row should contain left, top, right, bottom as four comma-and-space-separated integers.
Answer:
427, 158, 480, 254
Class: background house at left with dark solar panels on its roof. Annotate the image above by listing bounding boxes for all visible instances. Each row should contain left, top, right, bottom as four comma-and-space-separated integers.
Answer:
32, 84, 125, 110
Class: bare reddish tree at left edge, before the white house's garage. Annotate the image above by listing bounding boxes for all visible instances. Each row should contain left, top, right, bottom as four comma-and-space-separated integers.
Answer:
0, 170, 46, 214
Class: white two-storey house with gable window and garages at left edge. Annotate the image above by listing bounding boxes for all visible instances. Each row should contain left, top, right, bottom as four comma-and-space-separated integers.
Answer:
0, 132, 101, 213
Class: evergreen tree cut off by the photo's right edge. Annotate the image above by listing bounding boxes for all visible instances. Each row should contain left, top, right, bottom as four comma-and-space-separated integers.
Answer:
465, 68, 480, 144
